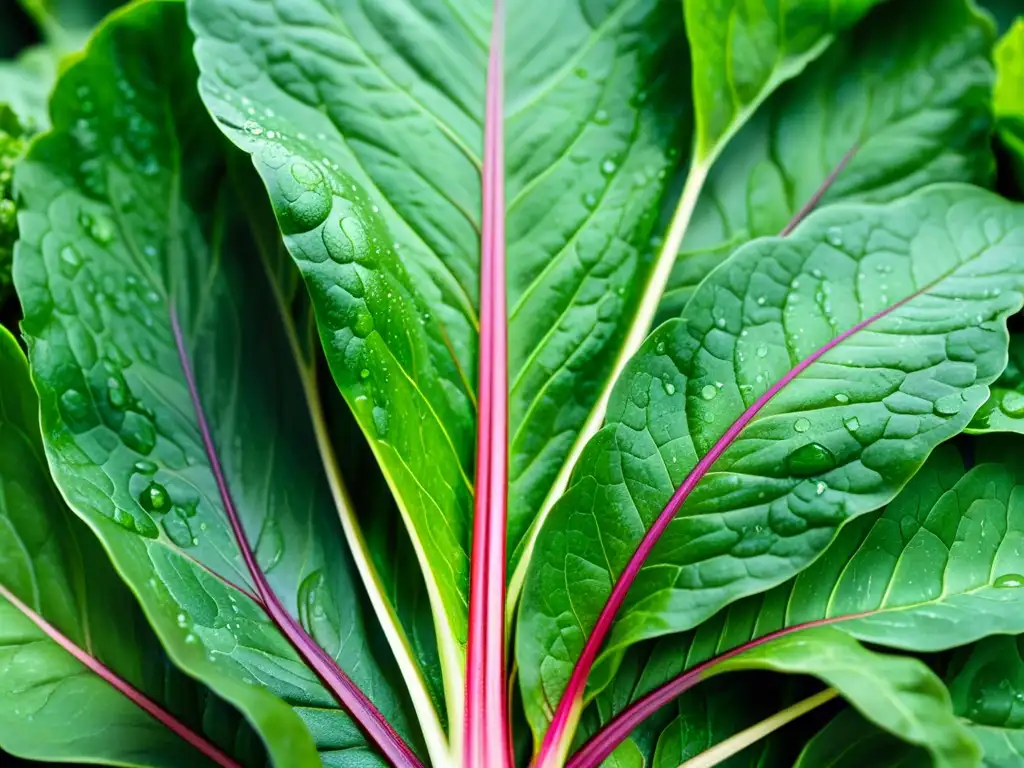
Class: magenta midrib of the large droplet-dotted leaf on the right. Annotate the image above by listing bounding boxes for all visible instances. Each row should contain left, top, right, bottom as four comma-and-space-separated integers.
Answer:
538, 285, 931, 766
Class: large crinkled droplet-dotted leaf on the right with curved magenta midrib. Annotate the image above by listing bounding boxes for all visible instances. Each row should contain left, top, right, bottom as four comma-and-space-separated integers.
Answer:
516, 185, 1024, 732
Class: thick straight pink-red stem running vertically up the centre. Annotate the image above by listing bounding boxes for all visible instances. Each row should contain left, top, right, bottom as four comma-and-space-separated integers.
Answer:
463, 0, 512, 768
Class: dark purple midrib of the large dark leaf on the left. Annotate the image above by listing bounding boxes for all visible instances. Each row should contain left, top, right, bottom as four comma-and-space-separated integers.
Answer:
171, 307, 421, 768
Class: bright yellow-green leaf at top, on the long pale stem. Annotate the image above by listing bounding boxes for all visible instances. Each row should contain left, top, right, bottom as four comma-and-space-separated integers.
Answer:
683, 0, 878, 164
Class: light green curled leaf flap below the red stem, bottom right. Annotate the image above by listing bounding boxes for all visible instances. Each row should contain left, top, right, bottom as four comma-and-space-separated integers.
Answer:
700, 627, 981, 768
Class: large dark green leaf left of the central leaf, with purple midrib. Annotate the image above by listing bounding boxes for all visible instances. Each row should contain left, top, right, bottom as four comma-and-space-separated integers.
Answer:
14, 2, 414, 766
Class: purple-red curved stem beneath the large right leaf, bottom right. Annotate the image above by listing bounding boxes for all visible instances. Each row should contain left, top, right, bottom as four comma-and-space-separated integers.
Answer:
565, 611, 872, 768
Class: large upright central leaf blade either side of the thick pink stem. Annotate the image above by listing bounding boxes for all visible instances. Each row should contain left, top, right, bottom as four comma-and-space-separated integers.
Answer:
190, 0, 685, 708
